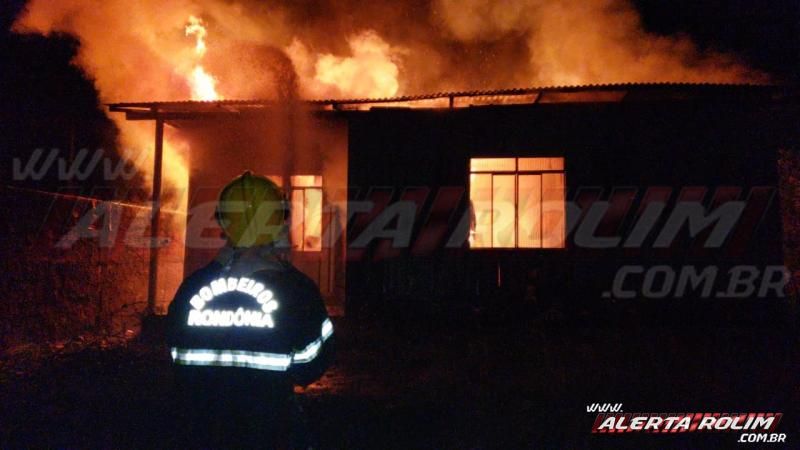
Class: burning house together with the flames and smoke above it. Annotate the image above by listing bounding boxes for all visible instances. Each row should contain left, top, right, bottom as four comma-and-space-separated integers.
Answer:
13, 0, 796, 328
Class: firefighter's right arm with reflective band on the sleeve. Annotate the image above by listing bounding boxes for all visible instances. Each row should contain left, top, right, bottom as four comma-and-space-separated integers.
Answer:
289, 286, 334, 386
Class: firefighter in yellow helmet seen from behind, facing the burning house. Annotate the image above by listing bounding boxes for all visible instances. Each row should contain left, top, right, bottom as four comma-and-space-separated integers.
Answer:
167, 171, 333, 447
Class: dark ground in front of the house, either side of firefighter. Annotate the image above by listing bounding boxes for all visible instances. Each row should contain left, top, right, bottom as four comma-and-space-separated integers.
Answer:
0, 314, 800, 449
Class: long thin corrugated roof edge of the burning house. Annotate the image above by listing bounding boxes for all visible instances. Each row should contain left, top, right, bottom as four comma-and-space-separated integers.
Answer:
108, 83, 797, 120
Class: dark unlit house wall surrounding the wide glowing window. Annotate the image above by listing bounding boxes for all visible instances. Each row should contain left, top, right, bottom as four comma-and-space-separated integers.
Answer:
348, 96, 796, 321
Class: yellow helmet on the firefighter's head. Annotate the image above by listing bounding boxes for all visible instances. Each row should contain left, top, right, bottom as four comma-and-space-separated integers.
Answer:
217, 170, 286, 247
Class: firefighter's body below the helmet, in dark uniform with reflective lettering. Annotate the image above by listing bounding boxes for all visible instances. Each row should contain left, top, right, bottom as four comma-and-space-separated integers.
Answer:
167, 261, 333, 447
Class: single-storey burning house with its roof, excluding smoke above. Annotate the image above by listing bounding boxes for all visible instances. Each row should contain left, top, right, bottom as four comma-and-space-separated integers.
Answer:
110, 84, 797, 321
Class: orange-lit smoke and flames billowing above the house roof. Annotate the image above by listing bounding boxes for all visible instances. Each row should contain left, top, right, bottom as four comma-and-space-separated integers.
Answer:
9, 0, 766, 199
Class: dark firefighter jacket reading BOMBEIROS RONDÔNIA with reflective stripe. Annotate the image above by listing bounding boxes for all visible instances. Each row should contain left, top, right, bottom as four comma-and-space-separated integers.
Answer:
167, 261, 333, 385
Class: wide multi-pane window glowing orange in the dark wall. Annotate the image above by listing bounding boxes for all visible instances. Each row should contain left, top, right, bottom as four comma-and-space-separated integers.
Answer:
469, 158, 566, 248
